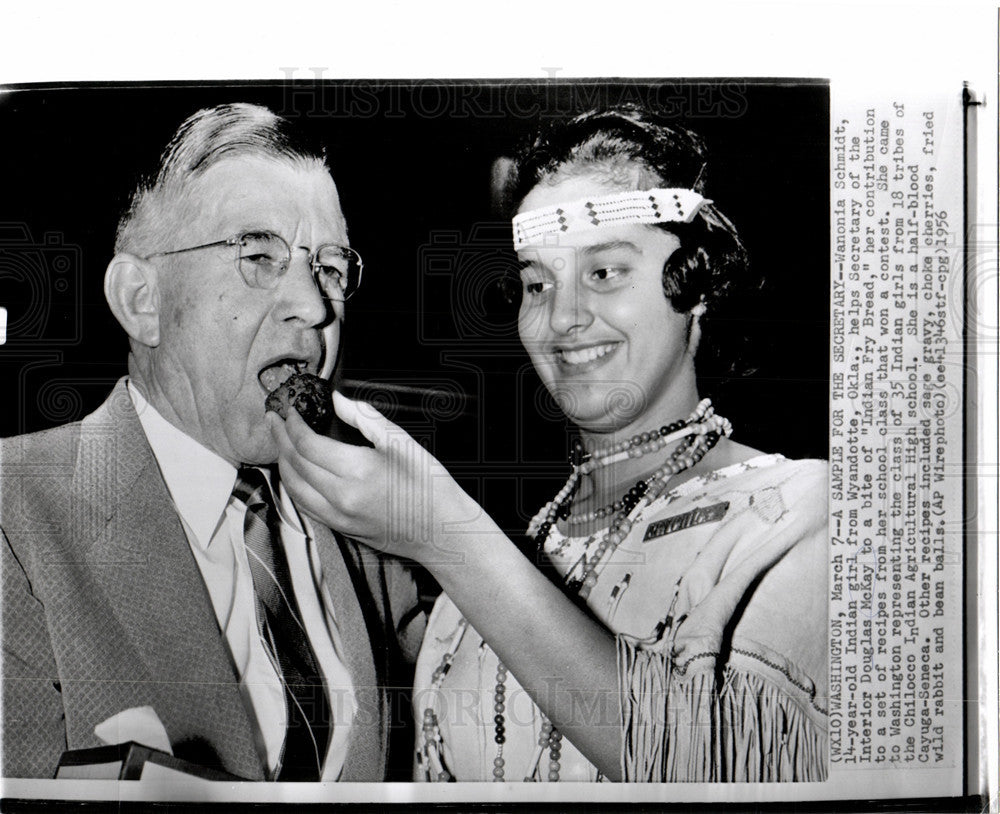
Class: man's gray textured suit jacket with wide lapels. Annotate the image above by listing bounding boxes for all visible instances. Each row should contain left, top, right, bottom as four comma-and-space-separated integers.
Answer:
0, 380, 421, 780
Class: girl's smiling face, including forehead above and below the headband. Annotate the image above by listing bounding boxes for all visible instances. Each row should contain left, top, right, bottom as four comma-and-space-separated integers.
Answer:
518, 175, 697, 433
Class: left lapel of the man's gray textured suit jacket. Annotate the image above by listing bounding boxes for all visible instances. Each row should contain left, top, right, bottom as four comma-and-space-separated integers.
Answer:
79, 382, 263, 779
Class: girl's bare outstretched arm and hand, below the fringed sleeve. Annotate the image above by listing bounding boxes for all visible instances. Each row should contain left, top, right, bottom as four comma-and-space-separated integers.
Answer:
268, 394, 622, 780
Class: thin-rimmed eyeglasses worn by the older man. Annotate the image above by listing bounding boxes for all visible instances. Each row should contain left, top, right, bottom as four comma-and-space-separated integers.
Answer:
143, 232, 364, 302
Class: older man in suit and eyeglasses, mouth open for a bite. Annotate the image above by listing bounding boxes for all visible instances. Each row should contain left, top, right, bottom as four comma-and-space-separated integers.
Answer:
0, 105, 420, 780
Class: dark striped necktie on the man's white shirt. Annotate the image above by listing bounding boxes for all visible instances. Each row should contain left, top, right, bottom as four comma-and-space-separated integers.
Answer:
233, 467, 332, 781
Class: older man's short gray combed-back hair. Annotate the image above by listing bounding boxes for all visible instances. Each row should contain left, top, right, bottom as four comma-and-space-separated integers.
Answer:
115, 103, 328, 255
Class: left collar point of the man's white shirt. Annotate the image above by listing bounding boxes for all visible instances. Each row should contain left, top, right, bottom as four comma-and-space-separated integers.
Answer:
128, 381, 236, 548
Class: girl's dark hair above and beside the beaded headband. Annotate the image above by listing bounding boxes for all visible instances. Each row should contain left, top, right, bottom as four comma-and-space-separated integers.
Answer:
504, 105, 762, 391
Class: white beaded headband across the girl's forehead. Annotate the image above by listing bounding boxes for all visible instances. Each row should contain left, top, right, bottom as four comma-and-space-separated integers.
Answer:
513, 189, 712, 251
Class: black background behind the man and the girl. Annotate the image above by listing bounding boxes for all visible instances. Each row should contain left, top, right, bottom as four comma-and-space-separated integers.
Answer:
0, 80, 829, 533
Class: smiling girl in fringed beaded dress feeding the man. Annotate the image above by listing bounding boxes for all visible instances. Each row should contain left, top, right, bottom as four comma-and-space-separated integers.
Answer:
274, 108, 828, 782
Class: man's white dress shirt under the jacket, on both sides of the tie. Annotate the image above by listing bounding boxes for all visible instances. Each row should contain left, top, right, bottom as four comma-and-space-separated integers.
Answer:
128, 382, 357, 780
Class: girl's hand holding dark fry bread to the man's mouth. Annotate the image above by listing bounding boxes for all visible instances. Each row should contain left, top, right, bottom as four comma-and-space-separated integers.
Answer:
266, 392, 482, 564
